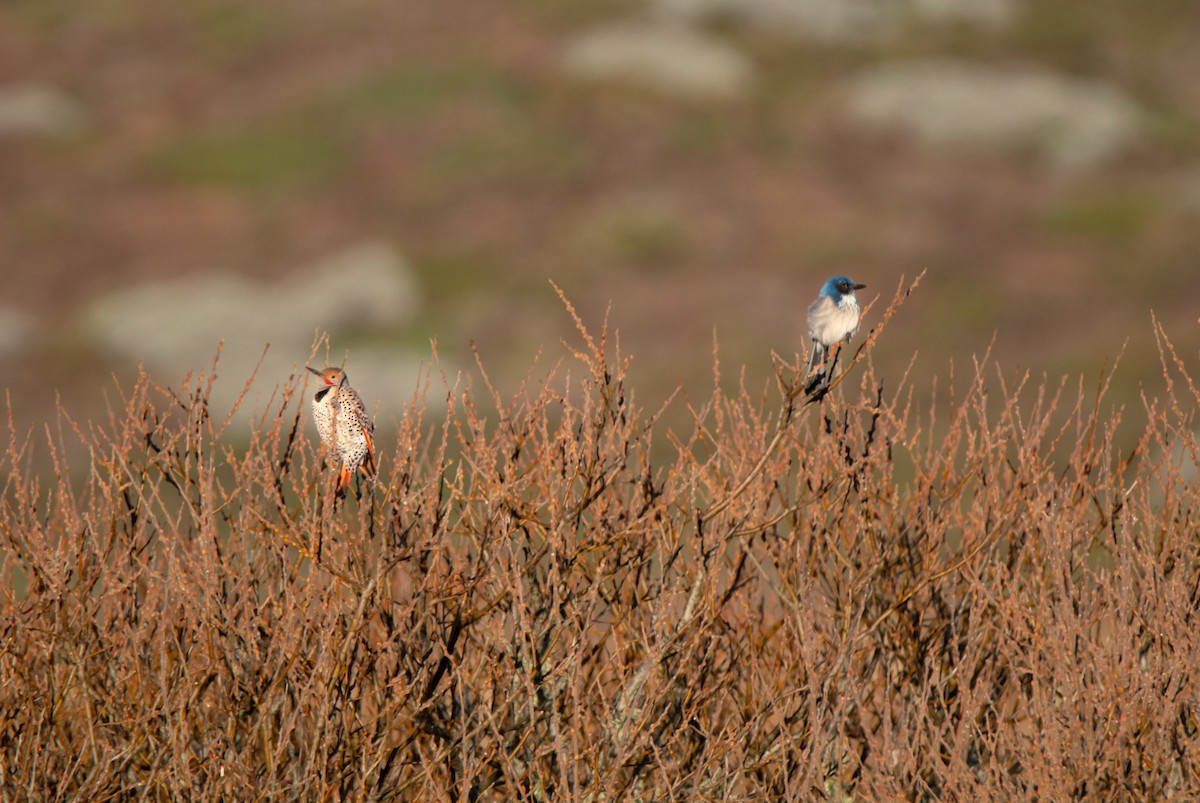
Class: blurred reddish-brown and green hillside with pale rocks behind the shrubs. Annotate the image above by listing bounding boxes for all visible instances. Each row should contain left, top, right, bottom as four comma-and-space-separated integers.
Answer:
0, 0, 1200, 439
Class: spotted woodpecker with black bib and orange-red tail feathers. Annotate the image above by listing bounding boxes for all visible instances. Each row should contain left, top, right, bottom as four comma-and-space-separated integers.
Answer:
305, 366, 376, 497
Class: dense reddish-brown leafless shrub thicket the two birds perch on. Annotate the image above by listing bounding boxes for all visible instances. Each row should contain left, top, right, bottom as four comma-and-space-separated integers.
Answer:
0, 280, 1200, 801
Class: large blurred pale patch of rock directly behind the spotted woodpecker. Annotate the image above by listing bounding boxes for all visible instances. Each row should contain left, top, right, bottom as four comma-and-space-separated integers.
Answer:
79, 244, 438, 415
